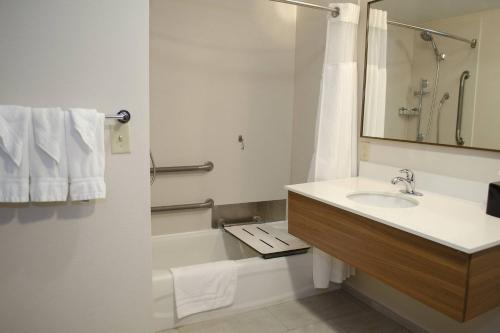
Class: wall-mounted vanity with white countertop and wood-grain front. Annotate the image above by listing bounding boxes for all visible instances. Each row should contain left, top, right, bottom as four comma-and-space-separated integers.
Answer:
288, 178, 500, 321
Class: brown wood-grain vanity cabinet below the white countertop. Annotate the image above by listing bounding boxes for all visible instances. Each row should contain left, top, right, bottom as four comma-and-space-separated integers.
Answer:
288, 192, 500, 322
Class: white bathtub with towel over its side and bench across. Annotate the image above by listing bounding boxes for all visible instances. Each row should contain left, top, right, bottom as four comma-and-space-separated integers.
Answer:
152, 222, 332, 332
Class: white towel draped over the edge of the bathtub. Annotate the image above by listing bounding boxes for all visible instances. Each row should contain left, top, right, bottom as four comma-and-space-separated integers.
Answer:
170, 260, 238, 319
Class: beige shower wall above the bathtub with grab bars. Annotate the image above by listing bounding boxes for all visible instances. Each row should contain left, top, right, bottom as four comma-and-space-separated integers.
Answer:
151, 0, 296, 234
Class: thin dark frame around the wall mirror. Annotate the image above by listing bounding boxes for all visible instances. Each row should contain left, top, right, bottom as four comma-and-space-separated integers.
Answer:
360, 0, 500, 153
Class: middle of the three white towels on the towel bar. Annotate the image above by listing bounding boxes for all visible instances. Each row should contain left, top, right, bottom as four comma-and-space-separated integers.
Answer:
29, 108, 68, 202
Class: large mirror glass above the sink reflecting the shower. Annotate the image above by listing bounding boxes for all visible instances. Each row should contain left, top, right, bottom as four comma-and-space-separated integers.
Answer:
362, 0, 500, 150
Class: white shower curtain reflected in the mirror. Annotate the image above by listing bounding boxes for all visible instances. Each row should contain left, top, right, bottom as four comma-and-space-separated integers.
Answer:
363, 9, 387, 137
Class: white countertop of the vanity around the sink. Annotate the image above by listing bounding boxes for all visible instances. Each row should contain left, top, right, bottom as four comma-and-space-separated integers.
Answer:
286, 177, 500, 254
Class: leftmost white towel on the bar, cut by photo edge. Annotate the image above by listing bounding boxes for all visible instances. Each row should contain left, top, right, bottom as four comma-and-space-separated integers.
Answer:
0, 106, 31, 202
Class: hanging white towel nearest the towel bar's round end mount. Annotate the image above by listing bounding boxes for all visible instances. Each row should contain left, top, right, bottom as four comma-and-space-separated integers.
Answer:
65, 109, 106, 201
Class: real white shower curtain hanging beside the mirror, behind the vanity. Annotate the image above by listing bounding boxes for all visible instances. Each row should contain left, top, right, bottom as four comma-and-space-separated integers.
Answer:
309, 3, 359, 288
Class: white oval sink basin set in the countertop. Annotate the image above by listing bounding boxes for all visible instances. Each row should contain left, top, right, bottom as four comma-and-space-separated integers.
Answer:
347, 192, 418, 208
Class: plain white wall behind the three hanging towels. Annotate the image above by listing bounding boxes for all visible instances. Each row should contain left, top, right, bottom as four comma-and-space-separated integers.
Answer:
0, 0, 151, 333
